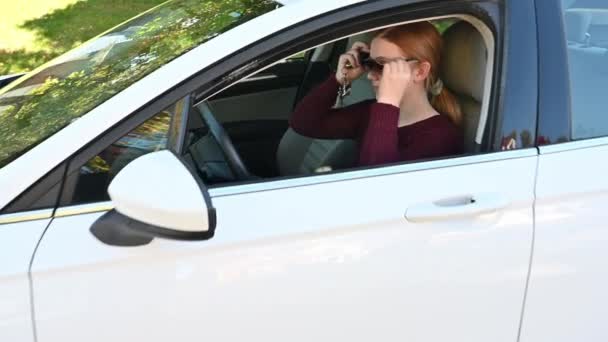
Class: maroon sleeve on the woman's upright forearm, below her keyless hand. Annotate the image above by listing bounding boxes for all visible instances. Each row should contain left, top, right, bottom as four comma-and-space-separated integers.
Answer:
359, 103, 401, 166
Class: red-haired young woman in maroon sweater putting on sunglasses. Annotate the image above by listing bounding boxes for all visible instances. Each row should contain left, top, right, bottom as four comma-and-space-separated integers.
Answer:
290, 22, 463, 166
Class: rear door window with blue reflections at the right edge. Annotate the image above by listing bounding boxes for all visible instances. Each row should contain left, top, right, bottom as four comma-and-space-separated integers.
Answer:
562, 0, 608, 140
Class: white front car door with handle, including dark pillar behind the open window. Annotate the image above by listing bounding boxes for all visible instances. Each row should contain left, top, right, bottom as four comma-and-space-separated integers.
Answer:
31, 2, 537, 342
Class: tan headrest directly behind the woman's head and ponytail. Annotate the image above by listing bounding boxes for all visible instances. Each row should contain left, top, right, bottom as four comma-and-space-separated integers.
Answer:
441, 21, 488, 102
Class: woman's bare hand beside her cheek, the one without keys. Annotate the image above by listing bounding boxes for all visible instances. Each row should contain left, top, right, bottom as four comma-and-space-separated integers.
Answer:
376, 59, 413, 107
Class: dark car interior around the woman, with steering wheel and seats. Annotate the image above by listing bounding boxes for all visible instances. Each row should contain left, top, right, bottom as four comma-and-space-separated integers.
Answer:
183, 19, 488, 186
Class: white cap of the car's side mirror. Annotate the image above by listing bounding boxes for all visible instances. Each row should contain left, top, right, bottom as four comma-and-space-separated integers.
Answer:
108, 150, 209, 232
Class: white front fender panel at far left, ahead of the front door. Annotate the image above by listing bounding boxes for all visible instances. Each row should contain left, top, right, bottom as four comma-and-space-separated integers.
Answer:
0, 219, 51, 342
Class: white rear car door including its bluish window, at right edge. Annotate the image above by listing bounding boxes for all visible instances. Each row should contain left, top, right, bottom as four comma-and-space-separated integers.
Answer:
521, 0, 608, 341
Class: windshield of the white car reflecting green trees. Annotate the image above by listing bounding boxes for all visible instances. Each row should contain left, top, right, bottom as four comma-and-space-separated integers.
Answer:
0, 0, 278, 168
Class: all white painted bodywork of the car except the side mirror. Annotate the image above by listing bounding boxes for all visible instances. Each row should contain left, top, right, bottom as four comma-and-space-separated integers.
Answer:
8, 1, 608, 342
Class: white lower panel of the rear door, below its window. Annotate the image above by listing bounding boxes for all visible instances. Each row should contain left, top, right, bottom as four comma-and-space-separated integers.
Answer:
521, 138, 608, 342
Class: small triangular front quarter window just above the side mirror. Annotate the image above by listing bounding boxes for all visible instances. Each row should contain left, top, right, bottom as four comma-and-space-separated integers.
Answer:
62, 98, 189, 205
